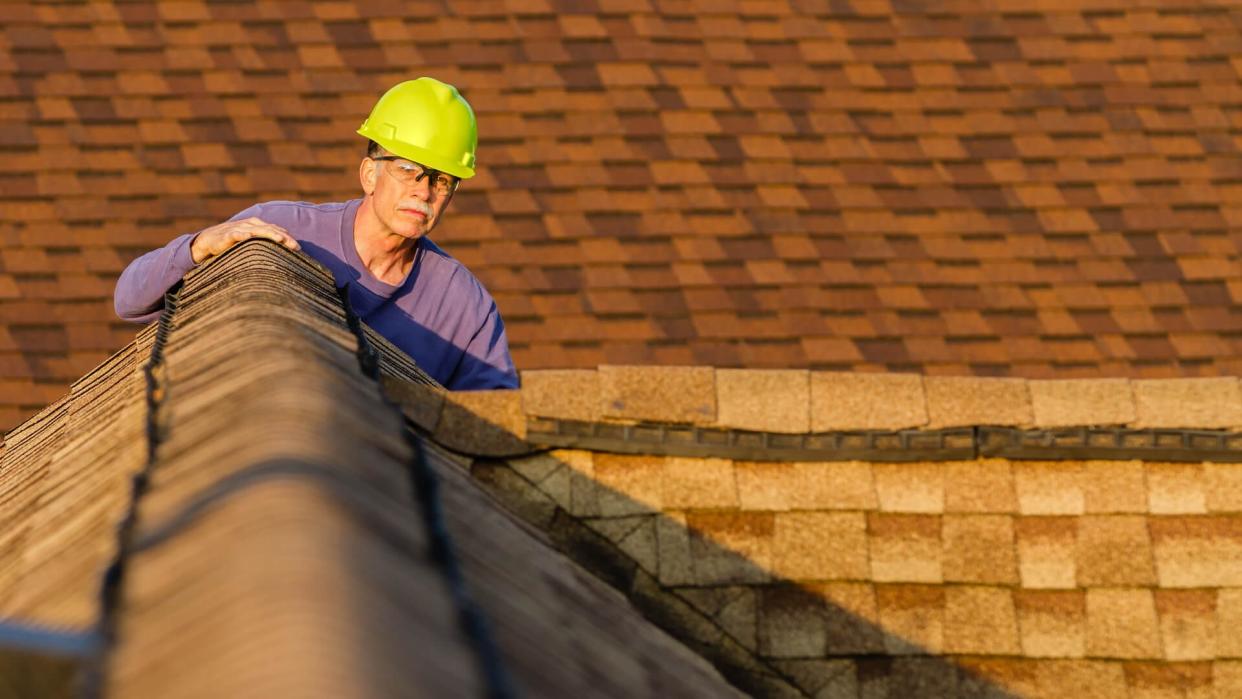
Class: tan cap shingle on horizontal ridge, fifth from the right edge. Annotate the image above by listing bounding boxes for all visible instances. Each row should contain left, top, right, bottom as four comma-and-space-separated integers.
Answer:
715, 369, 811, 432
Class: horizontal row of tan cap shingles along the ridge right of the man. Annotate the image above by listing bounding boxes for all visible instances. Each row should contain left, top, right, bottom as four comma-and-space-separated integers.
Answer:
514, 366, 1242, 433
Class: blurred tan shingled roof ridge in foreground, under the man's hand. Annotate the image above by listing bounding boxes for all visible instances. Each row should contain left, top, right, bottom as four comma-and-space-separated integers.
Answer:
0, 241, 735, 697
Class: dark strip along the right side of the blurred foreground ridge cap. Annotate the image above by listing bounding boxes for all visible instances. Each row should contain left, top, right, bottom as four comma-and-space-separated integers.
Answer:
337, 284, 517, 699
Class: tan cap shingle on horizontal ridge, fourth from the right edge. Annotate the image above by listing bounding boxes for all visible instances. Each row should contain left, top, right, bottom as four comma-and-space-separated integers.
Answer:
811, 371, 927, 432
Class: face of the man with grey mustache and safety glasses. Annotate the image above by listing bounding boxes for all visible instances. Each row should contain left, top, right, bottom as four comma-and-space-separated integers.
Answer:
359, 150, 452, 240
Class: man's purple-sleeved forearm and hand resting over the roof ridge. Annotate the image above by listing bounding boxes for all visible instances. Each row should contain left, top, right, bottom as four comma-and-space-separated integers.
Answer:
112, 214, 301, 323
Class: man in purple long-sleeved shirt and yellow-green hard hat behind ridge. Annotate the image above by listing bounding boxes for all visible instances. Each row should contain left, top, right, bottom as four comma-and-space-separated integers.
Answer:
114, 77, 518, 390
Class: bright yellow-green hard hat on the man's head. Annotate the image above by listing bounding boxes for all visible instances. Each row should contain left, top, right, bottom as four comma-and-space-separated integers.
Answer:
358, 77, 478, 180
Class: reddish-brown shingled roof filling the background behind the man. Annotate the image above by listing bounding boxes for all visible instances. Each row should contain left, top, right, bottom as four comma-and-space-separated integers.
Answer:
0, 0, 1242, 427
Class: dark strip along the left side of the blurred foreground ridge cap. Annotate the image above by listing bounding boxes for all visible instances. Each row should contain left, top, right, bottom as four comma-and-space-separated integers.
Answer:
81, 282, 181, 698
